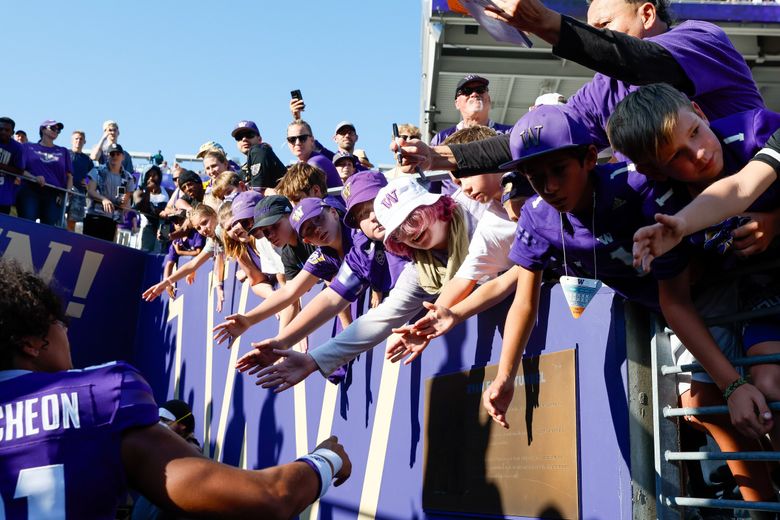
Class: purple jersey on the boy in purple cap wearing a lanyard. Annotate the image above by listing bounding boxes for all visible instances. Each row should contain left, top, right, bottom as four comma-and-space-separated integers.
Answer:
509, 163, 677, 310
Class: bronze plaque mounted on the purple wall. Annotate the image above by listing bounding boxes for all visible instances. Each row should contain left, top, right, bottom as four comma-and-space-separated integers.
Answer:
423, 349, 579, 519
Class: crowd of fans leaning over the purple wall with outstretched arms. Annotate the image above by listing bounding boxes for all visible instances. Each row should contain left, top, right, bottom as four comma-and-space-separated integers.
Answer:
0, 0, 780, 516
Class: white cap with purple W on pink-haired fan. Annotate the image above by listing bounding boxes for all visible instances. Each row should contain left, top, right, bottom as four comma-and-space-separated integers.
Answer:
374, 177, 441, 240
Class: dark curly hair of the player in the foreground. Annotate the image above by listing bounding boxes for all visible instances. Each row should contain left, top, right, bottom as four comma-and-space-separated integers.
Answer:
0, 258, 65, 370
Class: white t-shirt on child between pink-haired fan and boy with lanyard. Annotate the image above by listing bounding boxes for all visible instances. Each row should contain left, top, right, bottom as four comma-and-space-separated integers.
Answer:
455, 201, 517, 283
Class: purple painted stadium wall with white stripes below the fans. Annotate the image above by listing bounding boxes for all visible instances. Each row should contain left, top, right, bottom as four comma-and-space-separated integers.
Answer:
0, 216, 631, 519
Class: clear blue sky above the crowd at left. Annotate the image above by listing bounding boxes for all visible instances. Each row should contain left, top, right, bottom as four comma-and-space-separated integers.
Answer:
0, 0, 421, 169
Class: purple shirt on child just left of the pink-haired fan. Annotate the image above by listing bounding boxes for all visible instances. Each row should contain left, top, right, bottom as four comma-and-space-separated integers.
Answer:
330, 232, 407, 302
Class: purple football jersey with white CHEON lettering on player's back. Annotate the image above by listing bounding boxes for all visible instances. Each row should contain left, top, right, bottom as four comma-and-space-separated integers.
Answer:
0, 362, 159, 520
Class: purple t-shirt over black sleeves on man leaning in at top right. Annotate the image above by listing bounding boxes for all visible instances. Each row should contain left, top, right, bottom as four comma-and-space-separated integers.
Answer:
567, 20, 764, 149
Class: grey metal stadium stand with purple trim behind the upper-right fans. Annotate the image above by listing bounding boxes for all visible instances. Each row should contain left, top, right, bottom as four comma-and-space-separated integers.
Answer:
420, 0, 780, 137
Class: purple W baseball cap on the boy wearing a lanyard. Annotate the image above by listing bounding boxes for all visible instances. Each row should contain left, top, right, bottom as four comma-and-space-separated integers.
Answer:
499, 105, 593, 171
